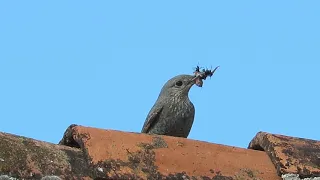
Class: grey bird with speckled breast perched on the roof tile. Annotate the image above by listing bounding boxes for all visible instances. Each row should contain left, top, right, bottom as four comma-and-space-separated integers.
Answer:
141, 74, 198, 138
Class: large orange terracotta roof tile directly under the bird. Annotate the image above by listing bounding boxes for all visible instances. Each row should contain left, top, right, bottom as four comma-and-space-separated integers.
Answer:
60, 126, 280, 180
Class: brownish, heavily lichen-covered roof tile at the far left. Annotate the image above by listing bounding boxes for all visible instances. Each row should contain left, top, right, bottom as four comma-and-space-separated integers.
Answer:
0, 129, 88, 179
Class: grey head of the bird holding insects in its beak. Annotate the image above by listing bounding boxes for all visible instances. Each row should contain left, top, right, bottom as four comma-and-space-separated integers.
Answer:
160, 75, 196, 97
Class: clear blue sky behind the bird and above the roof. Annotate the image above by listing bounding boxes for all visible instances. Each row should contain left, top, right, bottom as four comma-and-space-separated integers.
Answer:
0, 0, 320, 147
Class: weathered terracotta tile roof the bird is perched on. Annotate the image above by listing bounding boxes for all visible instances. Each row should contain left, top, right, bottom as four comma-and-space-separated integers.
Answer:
0, 125, 320, 180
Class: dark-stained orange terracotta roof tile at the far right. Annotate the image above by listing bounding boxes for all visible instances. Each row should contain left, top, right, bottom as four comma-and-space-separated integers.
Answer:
248, 132, 320, 178
